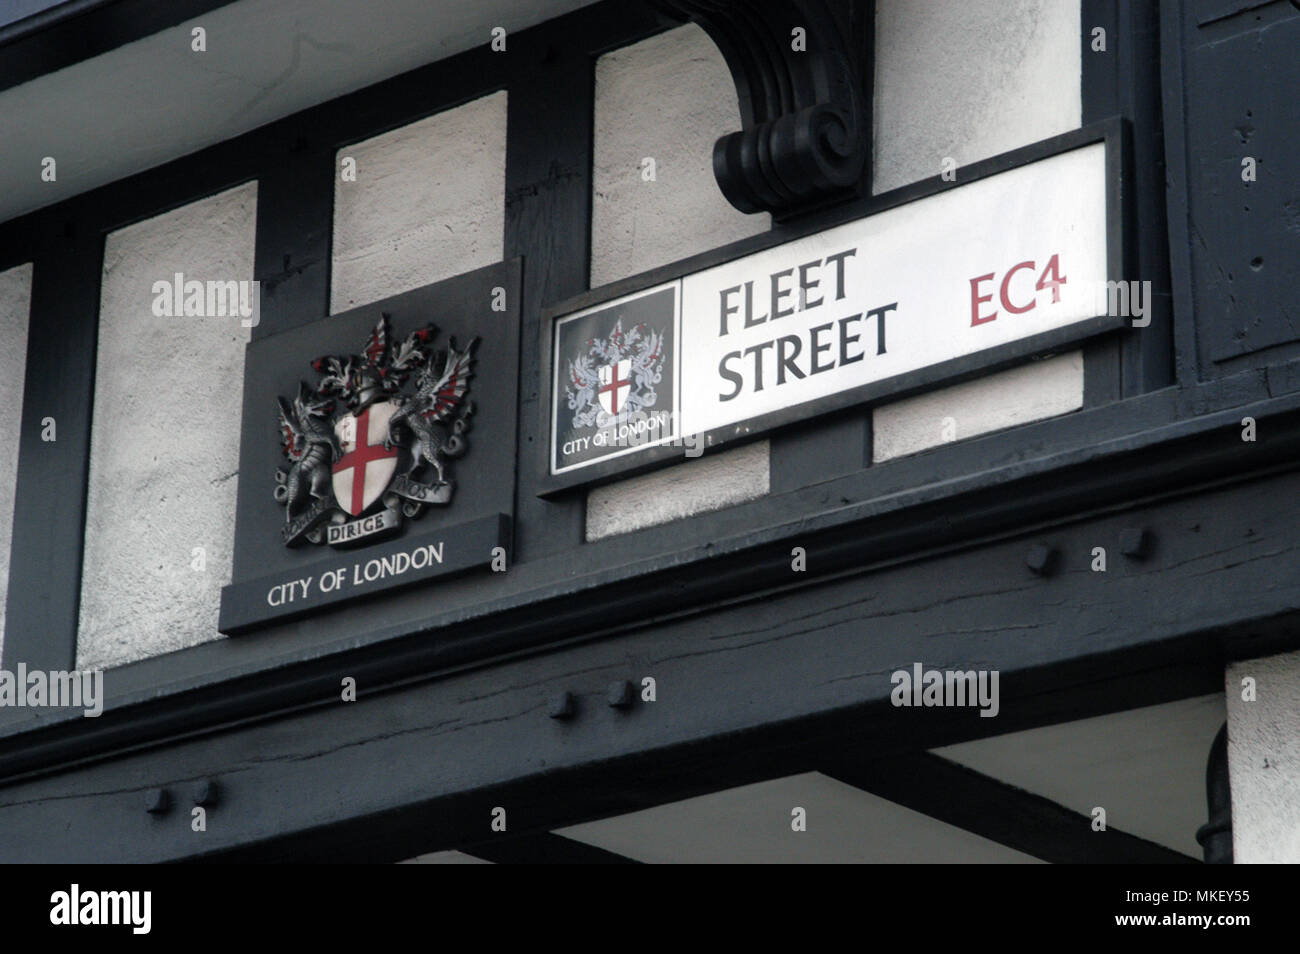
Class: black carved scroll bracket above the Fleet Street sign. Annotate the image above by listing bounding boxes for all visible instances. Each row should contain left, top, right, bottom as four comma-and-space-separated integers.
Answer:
651, 0, 875, 220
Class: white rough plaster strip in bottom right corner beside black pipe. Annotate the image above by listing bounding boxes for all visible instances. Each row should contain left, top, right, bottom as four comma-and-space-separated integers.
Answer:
1225, 652, 1300, 864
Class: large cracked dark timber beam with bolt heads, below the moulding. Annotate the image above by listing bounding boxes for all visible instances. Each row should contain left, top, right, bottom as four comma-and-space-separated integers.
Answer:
0, 527, 1237, 862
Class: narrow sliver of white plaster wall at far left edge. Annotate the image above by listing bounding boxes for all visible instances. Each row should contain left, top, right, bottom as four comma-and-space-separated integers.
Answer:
0, 264, 31, 651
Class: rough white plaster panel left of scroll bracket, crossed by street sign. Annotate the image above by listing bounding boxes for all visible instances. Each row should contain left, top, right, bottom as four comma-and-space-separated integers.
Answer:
586, 25, 771, 539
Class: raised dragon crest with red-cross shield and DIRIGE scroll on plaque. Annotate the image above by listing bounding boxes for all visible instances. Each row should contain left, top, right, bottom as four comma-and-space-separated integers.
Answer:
276, 315, 478, 546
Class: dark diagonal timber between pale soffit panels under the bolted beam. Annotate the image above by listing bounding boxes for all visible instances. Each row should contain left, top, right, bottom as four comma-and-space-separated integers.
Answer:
822, 753, 1197, 864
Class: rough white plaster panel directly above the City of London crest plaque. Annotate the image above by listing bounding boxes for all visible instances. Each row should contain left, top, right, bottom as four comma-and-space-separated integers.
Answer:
330, 92, 506, 313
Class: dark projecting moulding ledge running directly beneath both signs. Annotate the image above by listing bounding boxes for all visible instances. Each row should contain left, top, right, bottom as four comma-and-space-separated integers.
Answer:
0, 356, 1300, 753
